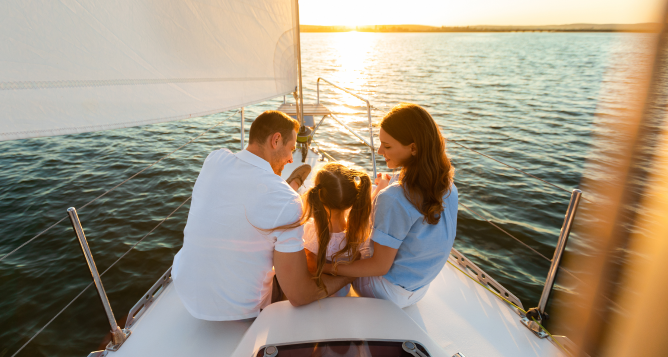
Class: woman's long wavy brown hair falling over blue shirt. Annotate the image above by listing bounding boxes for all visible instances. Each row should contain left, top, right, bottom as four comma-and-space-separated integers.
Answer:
380, 103, 454, 224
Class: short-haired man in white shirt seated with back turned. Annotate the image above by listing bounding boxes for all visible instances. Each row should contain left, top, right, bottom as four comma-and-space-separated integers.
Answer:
172, 111, 351, 321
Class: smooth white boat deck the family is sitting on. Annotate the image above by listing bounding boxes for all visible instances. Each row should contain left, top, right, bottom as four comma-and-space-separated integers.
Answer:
109, 152, 562, 357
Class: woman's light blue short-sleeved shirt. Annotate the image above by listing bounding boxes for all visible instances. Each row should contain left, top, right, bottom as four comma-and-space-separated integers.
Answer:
371, 183, 457, 291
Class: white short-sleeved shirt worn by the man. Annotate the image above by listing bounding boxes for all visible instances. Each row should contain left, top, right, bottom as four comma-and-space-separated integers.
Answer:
172, 149, 304, 321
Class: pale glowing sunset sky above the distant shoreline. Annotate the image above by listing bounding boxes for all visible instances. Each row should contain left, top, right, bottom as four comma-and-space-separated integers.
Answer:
299, 0, 663, 26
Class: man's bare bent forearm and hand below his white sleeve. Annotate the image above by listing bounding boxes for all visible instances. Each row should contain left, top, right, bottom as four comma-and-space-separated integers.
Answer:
274, 250, 355, 306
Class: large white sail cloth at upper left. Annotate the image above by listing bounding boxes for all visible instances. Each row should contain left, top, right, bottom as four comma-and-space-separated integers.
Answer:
0, 0, 298, 141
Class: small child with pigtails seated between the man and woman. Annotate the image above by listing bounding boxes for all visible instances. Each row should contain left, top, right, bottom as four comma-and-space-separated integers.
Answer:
300, 163, 371, 296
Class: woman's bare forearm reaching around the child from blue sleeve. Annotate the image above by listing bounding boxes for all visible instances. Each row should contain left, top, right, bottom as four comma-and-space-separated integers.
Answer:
323, 242, 399, 278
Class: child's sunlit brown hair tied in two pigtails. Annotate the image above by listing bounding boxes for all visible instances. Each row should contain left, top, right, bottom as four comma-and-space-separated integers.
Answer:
272, 163, 371, 295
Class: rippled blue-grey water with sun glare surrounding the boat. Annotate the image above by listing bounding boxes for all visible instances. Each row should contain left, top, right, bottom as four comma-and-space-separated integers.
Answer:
0, 32, 652, 356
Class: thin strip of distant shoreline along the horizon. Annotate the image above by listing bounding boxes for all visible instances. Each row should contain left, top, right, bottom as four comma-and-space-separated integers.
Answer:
299, 23, 661, 33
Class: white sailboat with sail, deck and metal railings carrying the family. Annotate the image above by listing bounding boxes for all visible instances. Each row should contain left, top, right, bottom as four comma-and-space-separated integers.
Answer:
0, 0, 664, 357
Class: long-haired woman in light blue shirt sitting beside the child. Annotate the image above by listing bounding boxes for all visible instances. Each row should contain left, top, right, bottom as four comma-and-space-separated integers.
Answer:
325, 103, 457, 308
